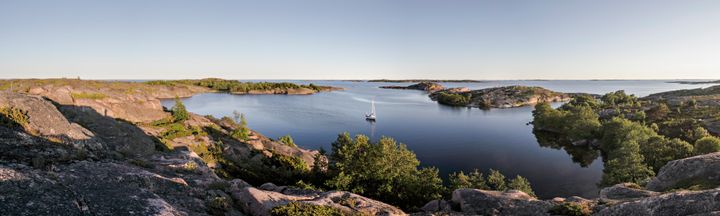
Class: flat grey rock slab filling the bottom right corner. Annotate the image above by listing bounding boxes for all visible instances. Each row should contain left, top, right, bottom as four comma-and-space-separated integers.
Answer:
595, 189, 720, 216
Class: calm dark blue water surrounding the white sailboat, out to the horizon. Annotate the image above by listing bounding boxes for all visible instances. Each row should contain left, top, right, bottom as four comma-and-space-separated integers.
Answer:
163, 80, 709, 198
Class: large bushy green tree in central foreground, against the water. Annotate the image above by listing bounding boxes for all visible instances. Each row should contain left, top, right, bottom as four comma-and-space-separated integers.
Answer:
325, 133, 444, 209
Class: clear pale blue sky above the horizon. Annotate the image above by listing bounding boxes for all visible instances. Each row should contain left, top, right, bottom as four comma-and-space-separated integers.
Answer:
0, 0, 720, 79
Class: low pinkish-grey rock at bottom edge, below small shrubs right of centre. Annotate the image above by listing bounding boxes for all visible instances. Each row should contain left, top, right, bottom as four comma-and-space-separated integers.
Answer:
452, 189, 553, 215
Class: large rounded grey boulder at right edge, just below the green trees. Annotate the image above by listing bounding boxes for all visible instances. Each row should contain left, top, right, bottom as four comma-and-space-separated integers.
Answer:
646, 152, 720, 191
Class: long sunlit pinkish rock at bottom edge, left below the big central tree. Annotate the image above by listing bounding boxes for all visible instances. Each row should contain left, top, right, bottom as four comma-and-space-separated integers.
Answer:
232, 184, 405, 216
